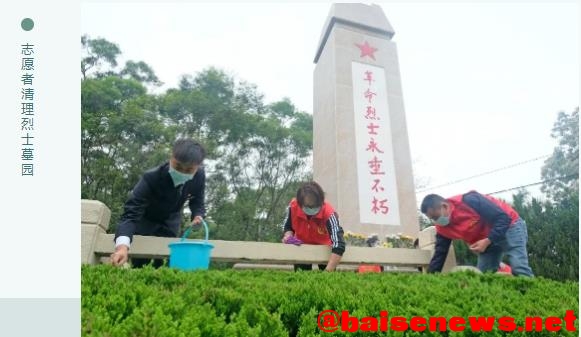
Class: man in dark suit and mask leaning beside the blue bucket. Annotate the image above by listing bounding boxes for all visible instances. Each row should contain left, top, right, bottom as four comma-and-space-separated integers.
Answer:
111, 139, 206, 267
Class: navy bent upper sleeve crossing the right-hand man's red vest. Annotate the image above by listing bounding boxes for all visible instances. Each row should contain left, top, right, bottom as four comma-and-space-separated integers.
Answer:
462, 192, 510, 243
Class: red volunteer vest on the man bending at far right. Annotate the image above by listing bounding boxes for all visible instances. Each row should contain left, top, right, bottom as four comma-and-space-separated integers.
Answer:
436, 195, 519, 244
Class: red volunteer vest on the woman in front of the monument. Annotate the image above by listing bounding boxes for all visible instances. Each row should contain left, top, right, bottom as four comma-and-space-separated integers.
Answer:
289, 199, 335, 246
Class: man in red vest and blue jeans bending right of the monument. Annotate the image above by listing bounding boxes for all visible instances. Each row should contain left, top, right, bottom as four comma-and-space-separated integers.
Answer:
421, 191, 533, 277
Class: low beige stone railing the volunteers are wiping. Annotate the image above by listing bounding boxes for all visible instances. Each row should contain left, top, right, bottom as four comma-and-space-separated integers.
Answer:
81, 200, 455, 271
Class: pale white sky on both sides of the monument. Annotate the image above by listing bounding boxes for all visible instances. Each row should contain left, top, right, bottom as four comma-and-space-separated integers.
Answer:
81, 2, 580, 203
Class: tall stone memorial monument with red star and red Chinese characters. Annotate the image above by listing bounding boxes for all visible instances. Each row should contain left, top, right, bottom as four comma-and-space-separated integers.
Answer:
313, 3, 419, 237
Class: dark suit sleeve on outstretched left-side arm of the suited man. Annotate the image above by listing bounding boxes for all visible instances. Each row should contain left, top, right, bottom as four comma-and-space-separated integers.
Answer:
115, 177, 152, 241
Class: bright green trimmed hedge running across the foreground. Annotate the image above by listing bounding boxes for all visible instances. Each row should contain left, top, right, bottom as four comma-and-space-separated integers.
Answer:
81, 265, 579, 337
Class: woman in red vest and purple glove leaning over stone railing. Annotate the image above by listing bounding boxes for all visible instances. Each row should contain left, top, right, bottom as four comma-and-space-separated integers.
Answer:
282, 182, 345, 271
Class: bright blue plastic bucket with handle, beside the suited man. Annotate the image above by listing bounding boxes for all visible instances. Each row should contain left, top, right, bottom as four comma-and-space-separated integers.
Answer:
168, 221, 214, 271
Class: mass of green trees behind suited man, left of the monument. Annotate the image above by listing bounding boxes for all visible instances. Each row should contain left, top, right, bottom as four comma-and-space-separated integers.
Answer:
81, 36, 312, 240
